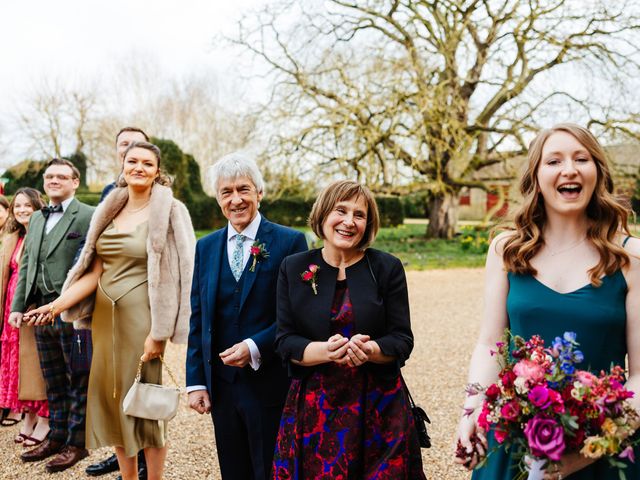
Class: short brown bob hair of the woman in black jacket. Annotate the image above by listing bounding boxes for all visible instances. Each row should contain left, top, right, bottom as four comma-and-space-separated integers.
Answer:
309, 180, 380, 250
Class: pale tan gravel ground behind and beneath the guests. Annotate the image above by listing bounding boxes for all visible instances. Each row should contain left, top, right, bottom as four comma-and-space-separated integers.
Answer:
0, 269, 483, 480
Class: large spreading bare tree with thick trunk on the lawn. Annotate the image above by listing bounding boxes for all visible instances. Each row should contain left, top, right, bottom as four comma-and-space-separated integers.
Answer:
232, 0, 640, 238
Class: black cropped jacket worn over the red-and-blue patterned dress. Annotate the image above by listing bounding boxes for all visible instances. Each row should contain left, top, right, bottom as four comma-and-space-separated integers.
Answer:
276, 248, 413, 378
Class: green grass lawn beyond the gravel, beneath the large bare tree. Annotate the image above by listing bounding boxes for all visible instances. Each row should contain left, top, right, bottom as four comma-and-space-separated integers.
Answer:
196, 224, 487, 270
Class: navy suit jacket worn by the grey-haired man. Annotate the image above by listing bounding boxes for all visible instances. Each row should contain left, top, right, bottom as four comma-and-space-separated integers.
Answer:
186, 216, 308, 395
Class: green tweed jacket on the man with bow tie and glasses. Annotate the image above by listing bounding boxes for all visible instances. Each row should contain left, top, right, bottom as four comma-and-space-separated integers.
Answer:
11, 198, 94, 312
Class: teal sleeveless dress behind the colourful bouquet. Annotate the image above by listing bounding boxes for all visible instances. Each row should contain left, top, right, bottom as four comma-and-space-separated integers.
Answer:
472, 270, 640, 480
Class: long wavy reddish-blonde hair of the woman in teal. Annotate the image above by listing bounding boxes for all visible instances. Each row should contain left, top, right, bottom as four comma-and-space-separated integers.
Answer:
503, 123, 630, 287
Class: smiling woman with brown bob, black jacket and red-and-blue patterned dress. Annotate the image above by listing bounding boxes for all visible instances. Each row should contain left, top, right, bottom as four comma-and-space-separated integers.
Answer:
271, 181, 425, 480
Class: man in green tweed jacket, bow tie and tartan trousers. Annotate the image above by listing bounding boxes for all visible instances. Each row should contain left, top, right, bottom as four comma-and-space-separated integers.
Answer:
9, 159, 93, 472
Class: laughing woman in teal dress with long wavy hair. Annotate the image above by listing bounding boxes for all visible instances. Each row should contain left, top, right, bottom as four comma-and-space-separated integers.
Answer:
457, 124, 640, 480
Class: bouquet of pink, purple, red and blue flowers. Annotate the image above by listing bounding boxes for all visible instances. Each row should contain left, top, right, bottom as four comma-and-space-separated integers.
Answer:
468, 332, 639, 478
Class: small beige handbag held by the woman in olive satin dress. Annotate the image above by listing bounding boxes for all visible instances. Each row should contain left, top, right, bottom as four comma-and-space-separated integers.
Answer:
122, 356, 181, 421
